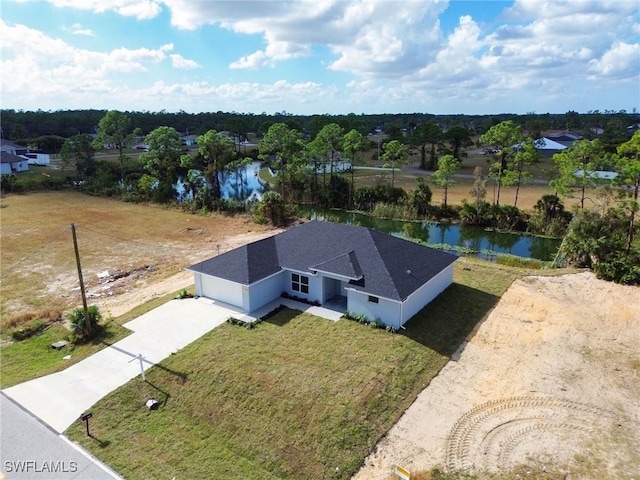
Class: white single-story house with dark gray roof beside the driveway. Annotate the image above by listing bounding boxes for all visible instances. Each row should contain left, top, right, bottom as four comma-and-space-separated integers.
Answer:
188, 221, 457, 328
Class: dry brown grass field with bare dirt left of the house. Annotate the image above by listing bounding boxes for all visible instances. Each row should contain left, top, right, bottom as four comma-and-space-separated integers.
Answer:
0, 191, 276, 323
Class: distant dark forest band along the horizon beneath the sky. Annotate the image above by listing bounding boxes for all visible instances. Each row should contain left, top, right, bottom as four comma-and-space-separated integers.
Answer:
0, 109, 640, 151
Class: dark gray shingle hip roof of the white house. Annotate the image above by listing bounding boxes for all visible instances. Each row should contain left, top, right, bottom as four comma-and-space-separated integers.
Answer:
189, 221, 457, 301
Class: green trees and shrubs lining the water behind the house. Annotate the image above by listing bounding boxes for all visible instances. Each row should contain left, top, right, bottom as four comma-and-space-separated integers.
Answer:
3, 111, 640, 283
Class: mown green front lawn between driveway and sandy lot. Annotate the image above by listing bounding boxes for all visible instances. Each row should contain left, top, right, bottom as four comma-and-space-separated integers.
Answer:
67, 259, 544, 480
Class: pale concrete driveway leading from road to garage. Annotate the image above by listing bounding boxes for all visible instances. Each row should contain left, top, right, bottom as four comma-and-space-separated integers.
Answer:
4, 298, 243, 432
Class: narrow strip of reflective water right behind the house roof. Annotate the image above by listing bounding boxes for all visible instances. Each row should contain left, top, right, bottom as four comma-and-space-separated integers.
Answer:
300, 206, 560, 261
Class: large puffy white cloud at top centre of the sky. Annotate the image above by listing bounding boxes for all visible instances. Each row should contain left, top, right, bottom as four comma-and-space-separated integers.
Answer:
159, 0, 448, 76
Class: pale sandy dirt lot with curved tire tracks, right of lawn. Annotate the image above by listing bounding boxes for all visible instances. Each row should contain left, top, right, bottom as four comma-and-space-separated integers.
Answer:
354, 273, 640, 480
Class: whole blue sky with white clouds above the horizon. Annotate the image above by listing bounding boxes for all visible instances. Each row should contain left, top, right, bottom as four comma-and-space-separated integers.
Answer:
0, 0, 640, 115
